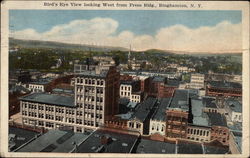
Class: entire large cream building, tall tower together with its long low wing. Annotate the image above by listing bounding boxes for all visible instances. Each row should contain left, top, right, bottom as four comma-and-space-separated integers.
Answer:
20, 67, 120, 132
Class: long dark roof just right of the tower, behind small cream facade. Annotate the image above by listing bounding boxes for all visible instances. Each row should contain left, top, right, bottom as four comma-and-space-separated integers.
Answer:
132, 97, 157, 122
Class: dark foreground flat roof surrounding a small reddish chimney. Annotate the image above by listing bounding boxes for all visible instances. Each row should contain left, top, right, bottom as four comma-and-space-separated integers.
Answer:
77, 130, 138, 153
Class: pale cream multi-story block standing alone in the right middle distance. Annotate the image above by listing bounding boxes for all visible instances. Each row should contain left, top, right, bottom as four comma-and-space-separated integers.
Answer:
190, 74, 205, 89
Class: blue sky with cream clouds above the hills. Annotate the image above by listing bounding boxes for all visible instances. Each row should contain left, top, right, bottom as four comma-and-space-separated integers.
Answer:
9, 10, 242, 52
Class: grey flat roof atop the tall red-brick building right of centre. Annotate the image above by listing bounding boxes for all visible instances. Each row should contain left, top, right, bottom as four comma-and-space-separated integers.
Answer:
169, 89, 189, 111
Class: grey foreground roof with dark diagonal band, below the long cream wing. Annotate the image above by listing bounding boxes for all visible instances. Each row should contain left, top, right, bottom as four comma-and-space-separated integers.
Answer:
17, 130, 88, 153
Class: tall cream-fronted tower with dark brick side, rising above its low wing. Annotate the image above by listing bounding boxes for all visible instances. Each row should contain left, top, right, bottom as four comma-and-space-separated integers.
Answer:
75, 67, 120, 127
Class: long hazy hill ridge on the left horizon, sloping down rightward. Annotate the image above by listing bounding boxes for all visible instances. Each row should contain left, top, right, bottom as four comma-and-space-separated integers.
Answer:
9, 38, 127, 52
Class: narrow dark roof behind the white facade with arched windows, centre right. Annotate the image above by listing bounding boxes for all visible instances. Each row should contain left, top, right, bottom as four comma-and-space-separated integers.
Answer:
152, 98, 171, 121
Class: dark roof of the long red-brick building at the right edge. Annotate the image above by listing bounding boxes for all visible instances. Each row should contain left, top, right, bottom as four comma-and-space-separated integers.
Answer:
208, 81, 242, 88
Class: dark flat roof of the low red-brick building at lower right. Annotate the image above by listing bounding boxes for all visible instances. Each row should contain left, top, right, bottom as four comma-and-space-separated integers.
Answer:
207, 112, 227, 127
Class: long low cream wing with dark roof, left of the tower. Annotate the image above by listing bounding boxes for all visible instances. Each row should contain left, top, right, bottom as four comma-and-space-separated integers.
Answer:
20, 93, 76, 130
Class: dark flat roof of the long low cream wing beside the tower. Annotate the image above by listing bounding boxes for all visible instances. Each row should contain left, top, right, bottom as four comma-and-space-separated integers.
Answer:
19, 93, 75, 107
